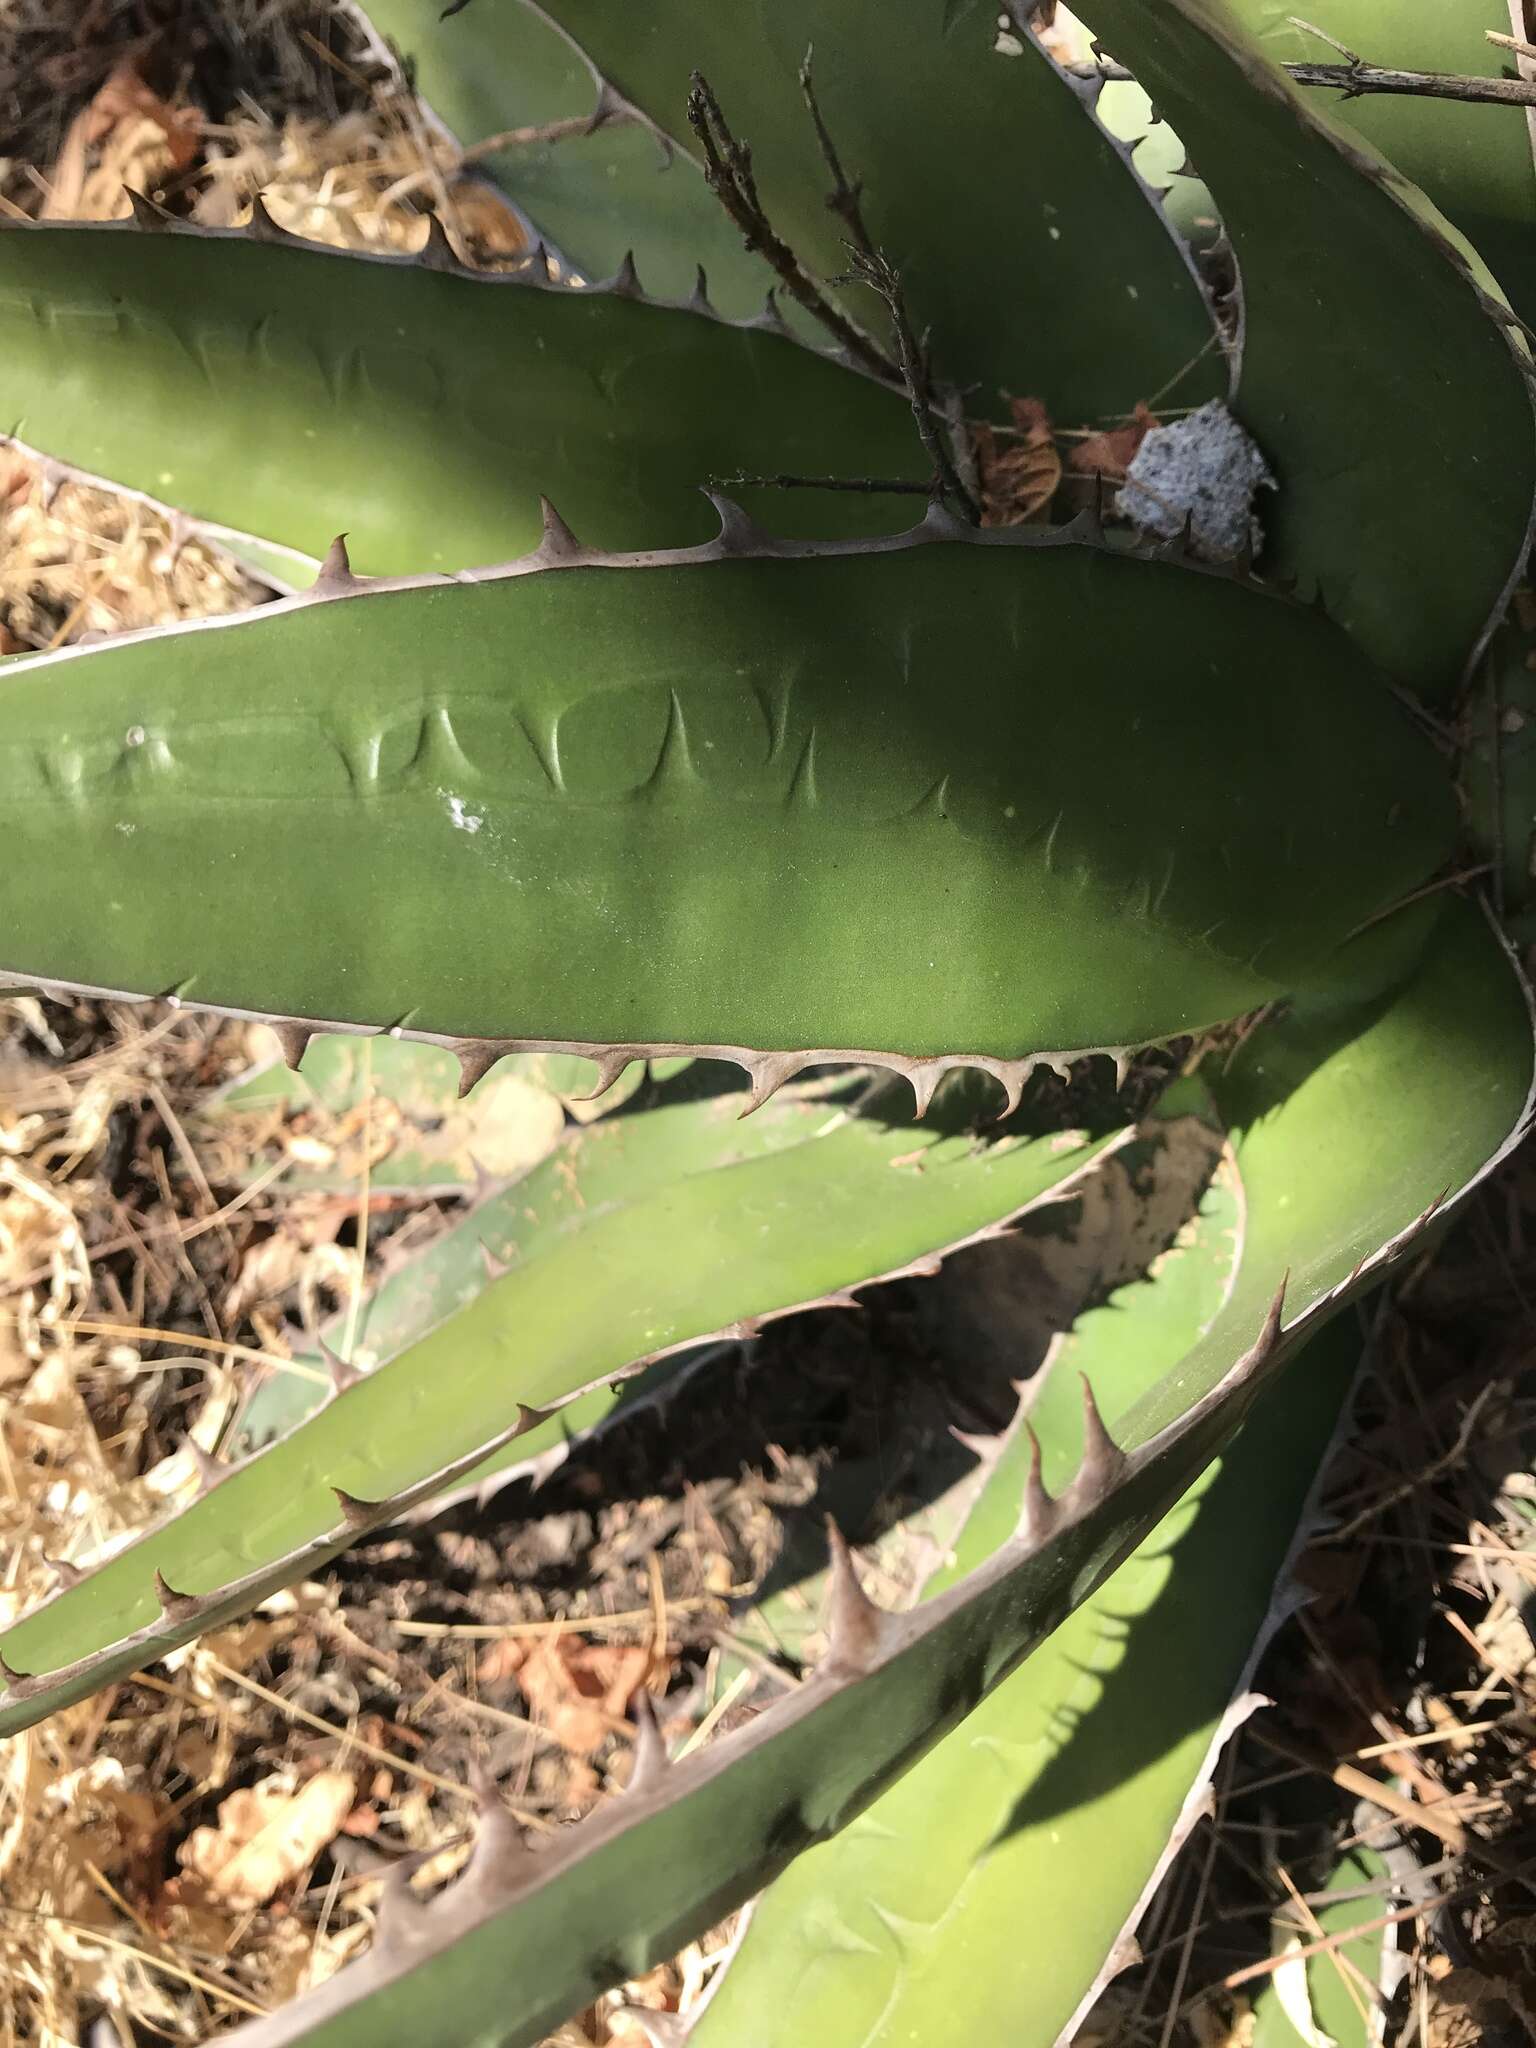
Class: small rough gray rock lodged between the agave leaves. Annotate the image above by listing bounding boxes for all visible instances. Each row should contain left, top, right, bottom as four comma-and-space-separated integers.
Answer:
1114, 397, 1276, 561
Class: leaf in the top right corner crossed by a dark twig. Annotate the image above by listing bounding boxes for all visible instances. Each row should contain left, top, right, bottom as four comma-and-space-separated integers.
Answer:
1229, 0, 1536, 319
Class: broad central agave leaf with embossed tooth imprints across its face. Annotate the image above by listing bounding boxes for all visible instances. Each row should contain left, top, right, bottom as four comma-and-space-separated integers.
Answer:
0, 512, 1452, 1094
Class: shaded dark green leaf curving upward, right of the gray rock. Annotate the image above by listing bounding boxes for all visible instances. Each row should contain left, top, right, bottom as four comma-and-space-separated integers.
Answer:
1090, 0, 1536, 700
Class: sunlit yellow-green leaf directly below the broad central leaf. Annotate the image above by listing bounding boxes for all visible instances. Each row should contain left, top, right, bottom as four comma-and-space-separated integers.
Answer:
0, 1081, 1126, 1735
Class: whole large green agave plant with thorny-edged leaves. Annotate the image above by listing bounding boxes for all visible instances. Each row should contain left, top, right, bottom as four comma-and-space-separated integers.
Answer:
0, 0, 1536, 2048
